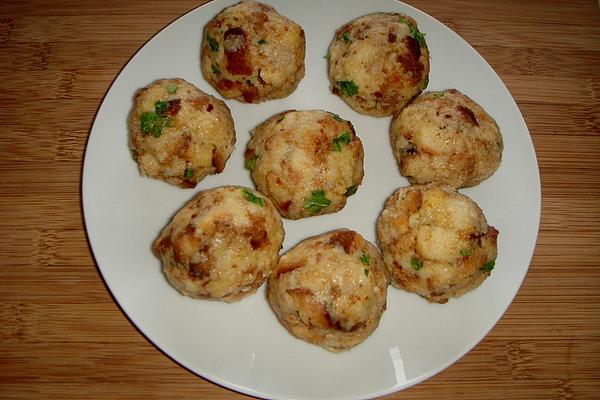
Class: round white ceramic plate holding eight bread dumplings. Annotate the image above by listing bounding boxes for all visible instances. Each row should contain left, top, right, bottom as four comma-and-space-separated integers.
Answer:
83, 0, 540, 399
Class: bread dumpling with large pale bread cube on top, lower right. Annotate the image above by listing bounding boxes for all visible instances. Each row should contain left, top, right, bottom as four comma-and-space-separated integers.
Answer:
377, 185, 498, 303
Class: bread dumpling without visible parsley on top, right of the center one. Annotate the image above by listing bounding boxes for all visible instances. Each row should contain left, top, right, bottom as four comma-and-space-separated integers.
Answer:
390, 89, 503, 188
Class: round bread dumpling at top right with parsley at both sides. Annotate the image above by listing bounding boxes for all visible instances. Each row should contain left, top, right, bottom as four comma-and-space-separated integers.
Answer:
328, 13, 429, 117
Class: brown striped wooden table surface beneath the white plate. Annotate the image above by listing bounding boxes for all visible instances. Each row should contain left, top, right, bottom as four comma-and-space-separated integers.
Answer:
0, 0, 600, 399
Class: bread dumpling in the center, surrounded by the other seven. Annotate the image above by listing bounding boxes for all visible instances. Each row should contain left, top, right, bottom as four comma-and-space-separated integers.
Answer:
245, 110, 364, 219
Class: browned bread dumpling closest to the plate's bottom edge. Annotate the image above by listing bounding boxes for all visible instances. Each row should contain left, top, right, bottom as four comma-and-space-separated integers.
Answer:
267, 229, 388, 352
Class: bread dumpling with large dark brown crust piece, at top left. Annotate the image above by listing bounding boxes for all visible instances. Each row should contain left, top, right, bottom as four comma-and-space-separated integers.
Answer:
201, 1, 306, 103
